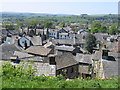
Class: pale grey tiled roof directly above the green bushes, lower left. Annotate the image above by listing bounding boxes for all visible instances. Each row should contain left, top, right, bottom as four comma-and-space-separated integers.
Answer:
12, 62, 56, 76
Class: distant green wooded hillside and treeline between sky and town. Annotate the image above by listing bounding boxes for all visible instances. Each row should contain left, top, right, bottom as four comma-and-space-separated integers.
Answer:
2, 12, 120, 34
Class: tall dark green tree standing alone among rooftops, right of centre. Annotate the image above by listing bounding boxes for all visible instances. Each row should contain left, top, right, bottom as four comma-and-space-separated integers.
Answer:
85, 34, 96, 53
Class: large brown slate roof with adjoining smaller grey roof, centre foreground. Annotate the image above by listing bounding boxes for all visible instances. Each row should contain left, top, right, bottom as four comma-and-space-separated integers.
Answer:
55, 52, 92, 70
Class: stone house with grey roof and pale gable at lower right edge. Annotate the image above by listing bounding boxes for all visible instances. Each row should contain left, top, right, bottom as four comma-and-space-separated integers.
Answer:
92, 48, 120, 78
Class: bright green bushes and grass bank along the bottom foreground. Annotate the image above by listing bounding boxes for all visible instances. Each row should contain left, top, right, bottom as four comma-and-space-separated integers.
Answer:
2, 63, 119, 88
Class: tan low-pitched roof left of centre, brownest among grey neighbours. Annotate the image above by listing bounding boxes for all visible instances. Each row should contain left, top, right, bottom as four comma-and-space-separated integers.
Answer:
26, 46, 52, 56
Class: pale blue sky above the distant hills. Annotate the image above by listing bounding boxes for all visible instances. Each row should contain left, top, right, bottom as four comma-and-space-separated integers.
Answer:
0, 0, 119, 15
